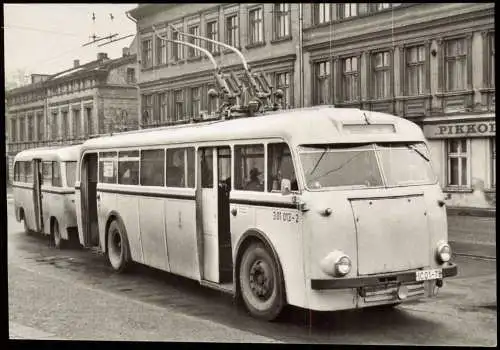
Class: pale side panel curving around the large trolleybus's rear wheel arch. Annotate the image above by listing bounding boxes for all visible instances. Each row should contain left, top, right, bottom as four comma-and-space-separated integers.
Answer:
105, 192, 144, 264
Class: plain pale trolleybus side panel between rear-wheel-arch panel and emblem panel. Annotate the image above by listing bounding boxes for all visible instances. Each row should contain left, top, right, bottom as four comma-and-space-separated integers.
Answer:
139, 198, 170, 271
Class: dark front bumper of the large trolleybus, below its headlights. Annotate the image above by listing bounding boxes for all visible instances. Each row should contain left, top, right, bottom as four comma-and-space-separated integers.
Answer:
311, 263, 458, 290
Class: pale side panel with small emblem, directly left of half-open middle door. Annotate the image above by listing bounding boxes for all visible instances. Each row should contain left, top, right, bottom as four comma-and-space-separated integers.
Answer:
165, 199, 199, 280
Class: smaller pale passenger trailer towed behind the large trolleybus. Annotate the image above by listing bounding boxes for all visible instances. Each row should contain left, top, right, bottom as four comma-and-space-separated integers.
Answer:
13, 145, 80, 248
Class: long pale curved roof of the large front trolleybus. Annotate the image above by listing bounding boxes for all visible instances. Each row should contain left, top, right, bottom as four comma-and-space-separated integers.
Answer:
78, 106, 425, 151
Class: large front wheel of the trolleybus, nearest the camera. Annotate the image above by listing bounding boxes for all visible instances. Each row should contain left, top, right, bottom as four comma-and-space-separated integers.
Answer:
239, 243, 285, 321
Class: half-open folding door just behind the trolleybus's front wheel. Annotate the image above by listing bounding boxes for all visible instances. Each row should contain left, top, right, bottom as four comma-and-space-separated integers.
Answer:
197, 147, 232, 283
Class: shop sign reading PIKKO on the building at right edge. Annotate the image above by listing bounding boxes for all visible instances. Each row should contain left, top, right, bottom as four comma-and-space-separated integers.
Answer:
424, 121, 495, 139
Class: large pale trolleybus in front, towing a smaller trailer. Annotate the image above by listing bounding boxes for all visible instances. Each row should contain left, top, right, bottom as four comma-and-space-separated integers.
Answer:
73, 106, 457, 320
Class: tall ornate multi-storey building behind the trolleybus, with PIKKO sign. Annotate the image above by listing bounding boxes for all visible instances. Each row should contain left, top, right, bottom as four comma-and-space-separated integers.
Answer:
130, 3, 496, 208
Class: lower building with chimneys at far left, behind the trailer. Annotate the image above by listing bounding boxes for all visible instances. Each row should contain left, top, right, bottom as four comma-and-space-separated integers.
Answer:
6, 48, 138, 182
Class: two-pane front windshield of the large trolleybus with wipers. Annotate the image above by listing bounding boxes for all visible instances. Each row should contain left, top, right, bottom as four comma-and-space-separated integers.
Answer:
299, 143, 435, 190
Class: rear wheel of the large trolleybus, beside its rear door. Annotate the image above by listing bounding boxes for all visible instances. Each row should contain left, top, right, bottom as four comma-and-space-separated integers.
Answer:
107, 220, 130, 272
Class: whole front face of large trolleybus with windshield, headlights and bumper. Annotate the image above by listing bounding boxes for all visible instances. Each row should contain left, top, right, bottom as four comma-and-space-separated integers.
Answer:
299, 142, 457, 310
